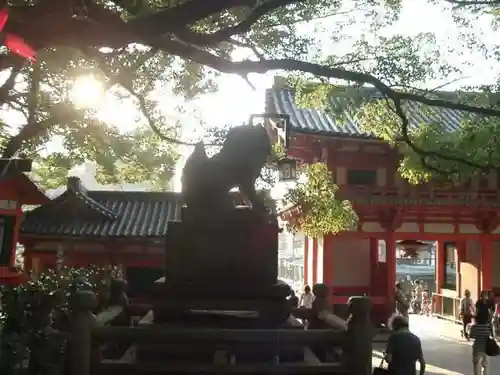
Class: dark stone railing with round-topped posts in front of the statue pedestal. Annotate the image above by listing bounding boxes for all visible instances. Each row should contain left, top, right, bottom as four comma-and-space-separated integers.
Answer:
64, 285, 382, 375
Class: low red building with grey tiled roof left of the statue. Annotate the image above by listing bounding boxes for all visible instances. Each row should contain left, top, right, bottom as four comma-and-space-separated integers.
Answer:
19, 177, 181, 297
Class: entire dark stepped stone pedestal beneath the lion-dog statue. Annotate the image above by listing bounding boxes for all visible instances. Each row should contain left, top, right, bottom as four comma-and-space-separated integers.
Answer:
153, 209, 291, 324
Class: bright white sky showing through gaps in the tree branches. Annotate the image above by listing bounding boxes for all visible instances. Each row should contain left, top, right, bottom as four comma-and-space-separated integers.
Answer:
0, 0, 500, 188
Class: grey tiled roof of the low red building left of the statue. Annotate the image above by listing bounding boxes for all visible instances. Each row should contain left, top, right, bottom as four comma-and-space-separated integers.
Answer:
21, 177, 181, 238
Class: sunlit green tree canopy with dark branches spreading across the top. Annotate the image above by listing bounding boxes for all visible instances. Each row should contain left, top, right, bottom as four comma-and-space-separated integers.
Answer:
0, 0, 500, 194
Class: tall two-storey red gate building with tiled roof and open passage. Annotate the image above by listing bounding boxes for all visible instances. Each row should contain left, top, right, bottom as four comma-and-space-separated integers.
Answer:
266, 78, 500, 319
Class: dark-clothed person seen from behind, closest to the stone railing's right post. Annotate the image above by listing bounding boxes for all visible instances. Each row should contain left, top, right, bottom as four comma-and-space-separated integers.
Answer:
386, 315, 425, 375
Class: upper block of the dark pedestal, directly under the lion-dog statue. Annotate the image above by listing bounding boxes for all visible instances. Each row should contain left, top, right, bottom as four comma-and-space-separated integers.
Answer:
165, 209, 279, 285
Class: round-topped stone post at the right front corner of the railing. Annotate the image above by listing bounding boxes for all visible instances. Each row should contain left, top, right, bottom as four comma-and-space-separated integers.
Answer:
345, 297, 375, 375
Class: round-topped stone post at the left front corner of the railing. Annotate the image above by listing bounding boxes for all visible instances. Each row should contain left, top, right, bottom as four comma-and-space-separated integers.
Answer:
68, 291, 97, 375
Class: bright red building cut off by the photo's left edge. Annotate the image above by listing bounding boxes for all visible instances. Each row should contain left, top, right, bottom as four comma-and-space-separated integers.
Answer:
0, 158, 49, 285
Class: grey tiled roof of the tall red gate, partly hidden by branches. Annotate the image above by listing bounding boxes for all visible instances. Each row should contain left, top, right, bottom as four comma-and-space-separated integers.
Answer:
266, 88, 462, 138
